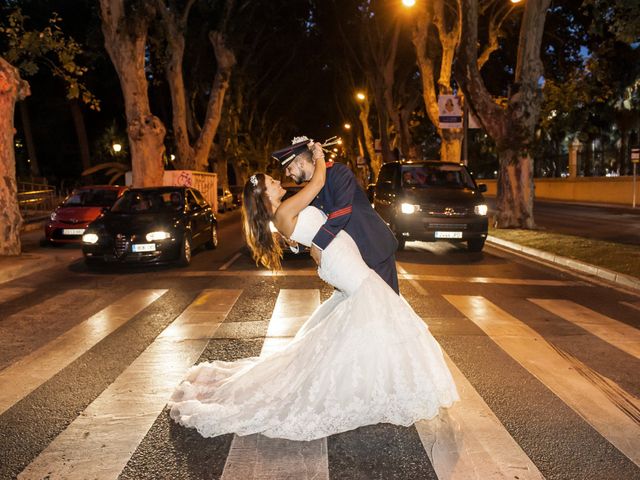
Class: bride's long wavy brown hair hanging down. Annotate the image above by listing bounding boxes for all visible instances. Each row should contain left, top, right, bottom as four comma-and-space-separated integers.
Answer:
242, 173, 282, 270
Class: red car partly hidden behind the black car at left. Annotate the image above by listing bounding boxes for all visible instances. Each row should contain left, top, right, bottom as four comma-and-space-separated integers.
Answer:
44, 185, 127, 245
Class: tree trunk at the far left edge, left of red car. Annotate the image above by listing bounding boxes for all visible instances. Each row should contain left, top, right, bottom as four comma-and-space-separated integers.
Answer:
0, 57, 30, 255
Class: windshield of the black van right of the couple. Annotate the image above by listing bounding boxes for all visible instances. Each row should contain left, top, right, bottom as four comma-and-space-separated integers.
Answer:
401, 164, 475, 189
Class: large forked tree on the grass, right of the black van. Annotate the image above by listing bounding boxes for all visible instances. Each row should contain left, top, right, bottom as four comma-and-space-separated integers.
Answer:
455, 0, 550, 228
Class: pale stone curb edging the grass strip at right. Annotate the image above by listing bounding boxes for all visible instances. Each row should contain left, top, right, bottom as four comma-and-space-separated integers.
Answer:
487, 235, 640, 291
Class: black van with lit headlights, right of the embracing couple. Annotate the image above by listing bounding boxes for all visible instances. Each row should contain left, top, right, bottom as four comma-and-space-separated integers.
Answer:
373, 160, 489, 252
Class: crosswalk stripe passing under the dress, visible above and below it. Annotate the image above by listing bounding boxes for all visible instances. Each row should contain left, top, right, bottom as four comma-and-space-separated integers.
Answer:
221, 289, 329, 480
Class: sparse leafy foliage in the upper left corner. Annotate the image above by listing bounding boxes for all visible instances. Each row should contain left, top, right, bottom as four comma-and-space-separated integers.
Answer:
0, 8, 100, 110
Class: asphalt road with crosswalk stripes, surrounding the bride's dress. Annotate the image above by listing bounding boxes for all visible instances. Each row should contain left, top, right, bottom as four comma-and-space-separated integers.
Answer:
0, 211, 640, 480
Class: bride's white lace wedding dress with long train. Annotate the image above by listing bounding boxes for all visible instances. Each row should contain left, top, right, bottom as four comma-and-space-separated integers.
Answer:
169, 206, 458, 440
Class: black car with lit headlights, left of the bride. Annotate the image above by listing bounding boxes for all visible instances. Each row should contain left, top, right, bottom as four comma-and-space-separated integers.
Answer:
82, 187, 218, 266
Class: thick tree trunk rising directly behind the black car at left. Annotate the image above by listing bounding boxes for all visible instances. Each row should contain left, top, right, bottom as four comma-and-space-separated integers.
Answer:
100, 0, 166, 187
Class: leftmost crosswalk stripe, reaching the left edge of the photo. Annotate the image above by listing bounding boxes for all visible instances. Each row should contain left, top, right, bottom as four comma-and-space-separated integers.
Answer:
0, 289, 167, 414
